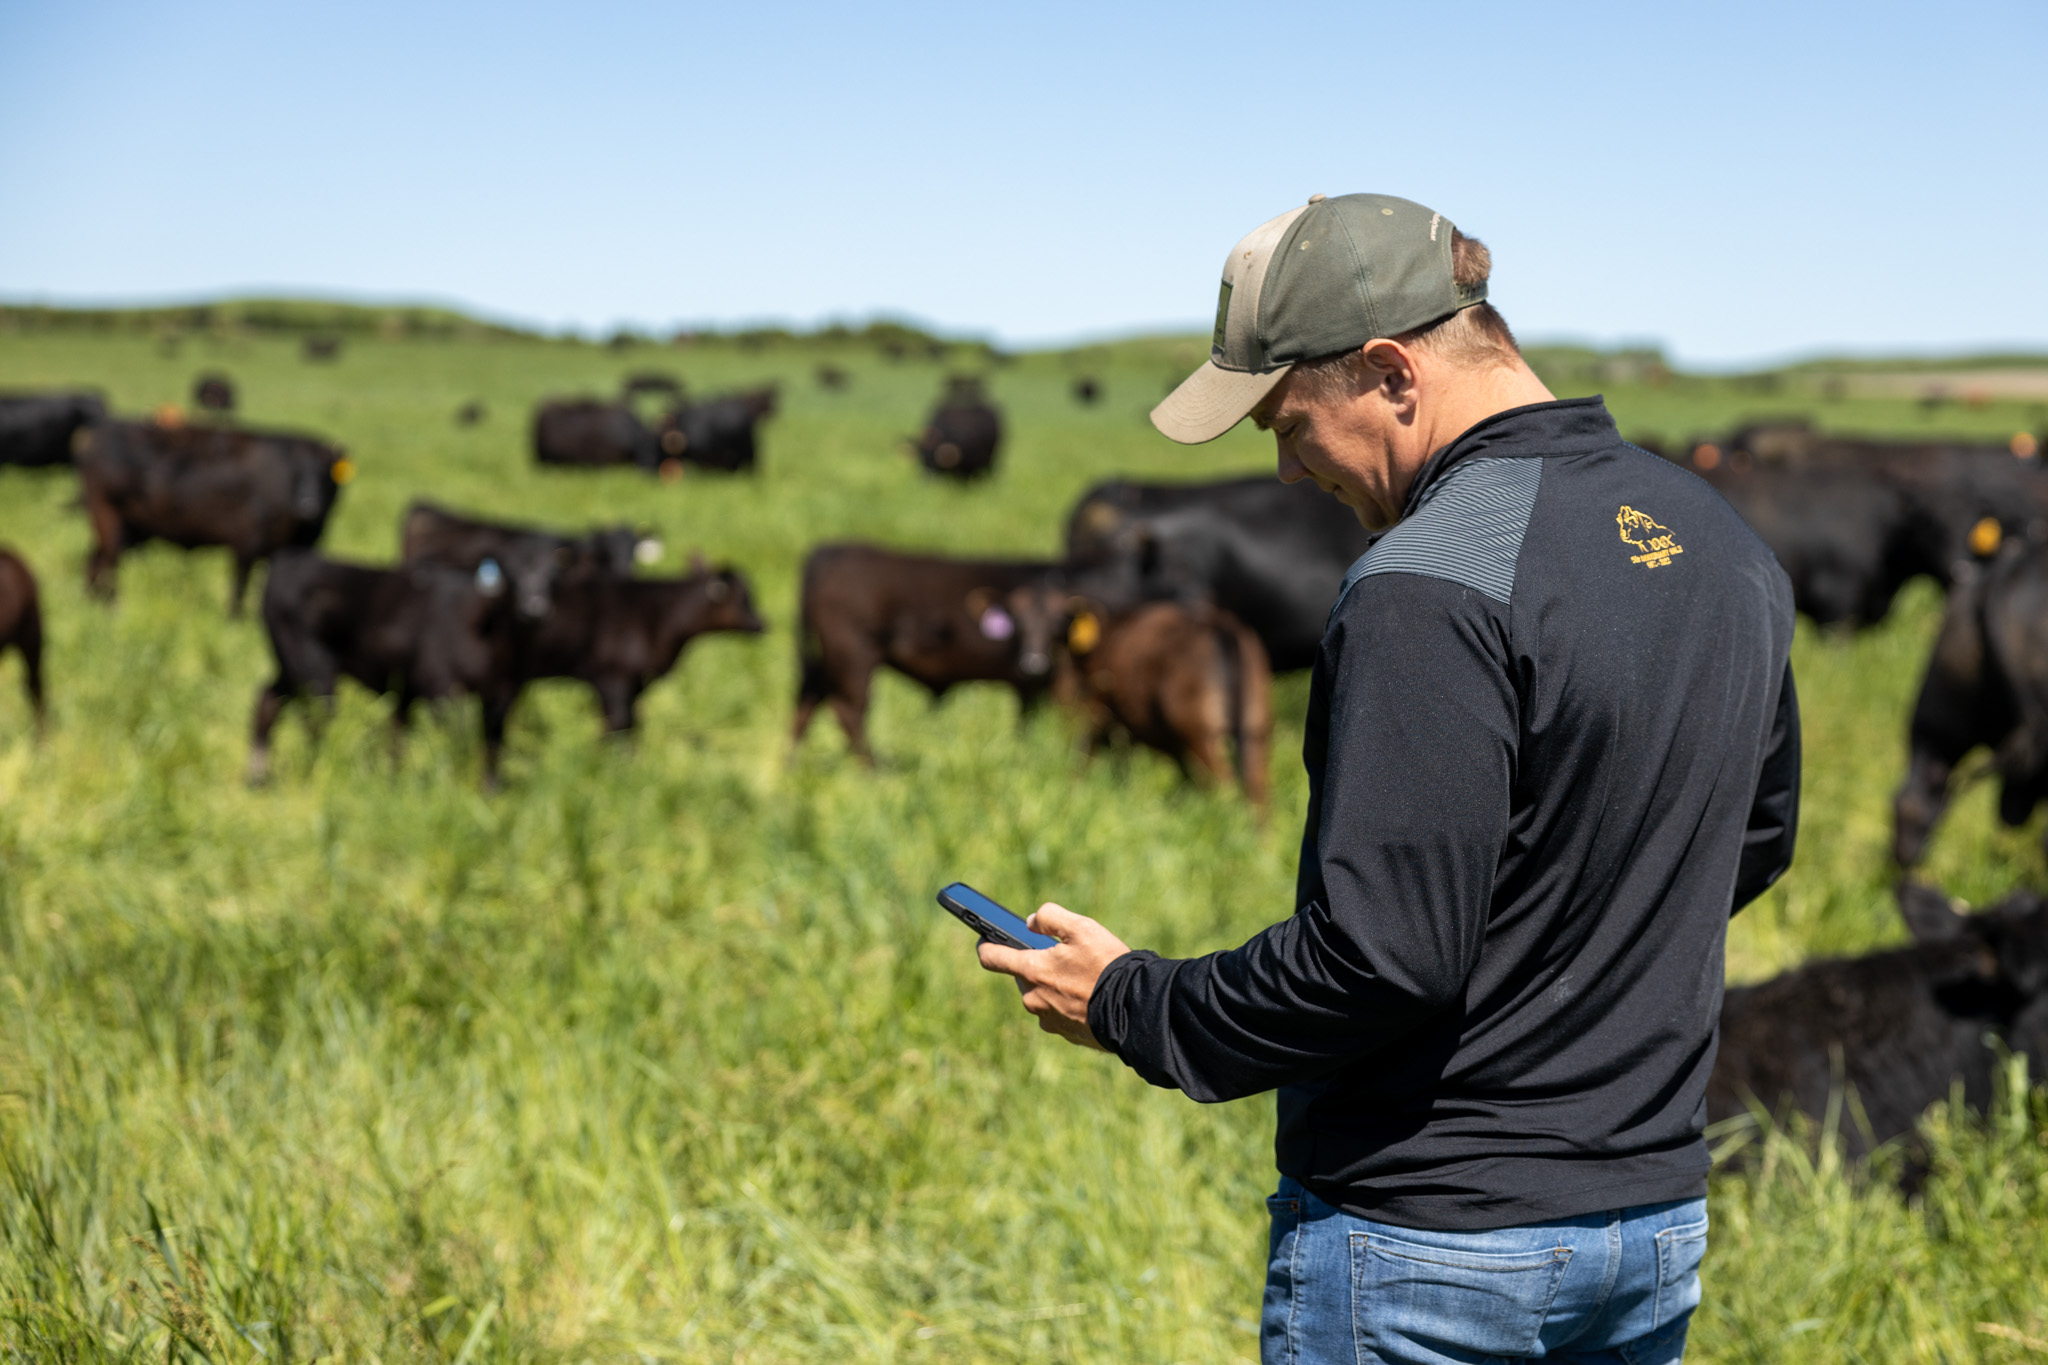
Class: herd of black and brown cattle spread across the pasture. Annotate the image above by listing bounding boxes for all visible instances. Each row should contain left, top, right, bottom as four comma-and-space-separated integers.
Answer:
0, 383, 2048, 1170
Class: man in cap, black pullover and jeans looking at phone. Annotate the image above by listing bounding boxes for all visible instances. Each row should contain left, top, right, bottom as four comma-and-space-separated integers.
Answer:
981, 194, 1798, 1365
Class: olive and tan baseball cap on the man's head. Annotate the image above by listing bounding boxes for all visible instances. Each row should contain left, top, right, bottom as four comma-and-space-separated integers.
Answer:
1153, 194, 1487, 446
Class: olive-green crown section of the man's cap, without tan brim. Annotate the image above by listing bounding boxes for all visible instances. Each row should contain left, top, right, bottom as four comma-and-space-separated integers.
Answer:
1257, 194, 1487, 368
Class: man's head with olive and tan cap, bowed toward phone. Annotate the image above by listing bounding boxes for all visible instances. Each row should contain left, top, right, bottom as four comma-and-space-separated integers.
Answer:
1153, 194, 1550, 526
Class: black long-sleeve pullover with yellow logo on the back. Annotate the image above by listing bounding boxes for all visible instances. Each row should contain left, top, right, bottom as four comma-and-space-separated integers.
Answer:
1087, 399, 1798, 1228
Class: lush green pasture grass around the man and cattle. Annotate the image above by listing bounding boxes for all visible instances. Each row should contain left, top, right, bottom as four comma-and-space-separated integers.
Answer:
0, 325, 2048, 1363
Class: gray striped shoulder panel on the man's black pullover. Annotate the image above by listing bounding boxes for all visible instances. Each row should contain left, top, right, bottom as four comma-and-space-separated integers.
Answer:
1329, 456, 1542, 618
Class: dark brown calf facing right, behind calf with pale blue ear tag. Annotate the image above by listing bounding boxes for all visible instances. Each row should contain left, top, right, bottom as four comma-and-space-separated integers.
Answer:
516, 561, 768, 733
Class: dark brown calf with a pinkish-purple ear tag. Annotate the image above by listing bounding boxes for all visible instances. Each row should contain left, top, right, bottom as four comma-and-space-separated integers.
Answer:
791, 544, 1059, 763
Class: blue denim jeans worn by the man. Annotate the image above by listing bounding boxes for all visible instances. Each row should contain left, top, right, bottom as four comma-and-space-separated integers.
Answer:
1260, 1179, 1706, 1365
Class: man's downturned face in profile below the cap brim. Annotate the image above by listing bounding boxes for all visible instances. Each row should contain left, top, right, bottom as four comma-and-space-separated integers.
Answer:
1251, 375, 1407, 530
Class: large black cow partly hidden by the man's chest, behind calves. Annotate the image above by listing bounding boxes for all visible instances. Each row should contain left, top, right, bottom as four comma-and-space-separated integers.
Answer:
1067, 477, 1376, 671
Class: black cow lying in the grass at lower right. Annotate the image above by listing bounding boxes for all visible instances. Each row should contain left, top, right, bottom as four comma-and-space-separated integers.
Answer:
1706, 884, 2048, 1154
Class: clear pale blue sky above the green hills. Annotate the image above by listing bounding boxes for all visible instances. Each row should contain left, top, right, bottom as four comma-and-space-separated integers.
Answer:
0, 0, 2048, 364
